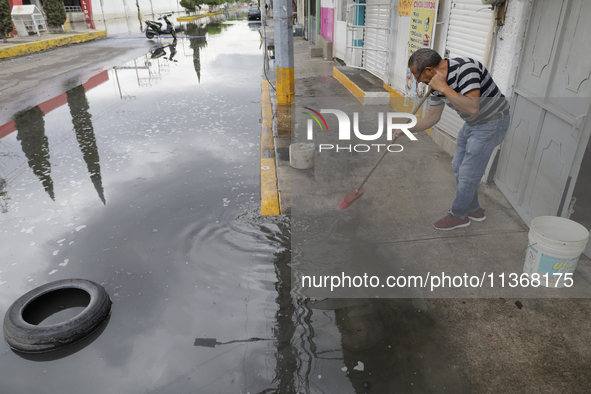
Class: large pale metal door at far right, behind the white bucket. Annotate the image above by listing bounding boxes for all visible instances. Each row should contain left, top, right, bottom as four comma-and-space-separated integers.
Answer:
495, 0, 591, 254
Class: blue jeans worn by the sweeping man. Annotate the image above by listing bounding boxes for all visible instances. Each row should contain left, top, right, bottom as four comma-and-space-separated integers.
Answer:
450, 115, 511, 219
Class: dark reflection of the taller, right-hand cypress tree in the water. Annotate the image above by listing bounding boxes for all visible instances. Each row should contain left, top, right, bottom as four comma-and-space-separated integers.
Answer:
66, 85, 107, 204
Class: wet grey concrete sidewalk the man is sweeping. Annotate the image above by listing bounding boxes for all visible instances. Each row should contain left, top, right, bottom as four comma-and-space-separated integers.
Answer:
263, 30, 591, 393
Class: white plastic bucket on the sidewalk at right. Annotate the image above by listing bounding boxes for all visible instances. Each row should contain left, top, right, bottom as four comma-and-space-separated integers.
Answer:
523, 216, 589, 287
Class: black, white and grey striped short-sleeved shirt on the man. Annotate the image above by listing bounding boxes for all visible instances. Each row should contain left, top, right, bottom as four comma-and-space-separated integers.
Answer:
431, 57, 509, 125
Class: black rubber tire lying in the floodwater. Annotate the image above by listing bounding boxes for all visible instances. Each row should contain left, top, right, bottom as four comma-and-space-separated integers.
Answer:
4, 279, 111, 353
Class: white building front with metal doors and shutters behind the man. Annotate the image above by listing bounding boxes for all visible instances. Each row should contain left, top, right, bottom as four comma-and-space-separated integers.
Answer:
328, 0, 591, 255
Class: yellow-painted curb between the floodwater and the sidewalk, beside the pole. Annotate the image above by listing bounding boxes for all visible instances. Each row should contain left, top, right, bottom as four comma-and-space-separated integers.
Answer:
260, 79, 281, 216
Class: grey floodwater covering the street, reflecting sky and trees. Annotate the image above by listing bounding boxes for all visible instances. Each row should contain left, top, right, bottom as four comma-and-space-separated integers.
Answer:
0, 13, 472, 394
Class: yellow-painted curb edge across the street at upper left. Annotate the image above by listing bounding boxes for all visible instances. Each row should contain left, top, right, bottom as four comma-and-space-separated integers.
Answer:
0, 30, 107, 59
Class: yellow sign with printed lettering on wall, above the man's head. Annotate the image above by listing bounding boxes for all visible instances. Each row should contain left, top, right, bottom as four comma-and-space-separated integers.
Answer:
406, 0, 437, 96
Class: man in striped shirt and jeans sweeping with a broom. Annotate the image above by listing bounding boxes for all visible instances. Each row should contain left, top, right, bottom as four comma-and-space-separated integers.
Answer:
395, 48, 510, 230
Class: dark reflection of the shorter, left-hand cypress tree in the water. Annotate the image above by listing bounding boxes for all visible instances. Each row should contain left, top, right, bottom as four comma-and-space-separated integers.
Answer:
14, 106, 55, 200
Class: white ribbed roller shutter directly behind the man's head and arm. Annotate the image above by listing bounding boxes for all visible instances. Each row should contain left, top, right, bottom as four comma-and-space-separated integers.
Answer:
435, 0, 494, 138
